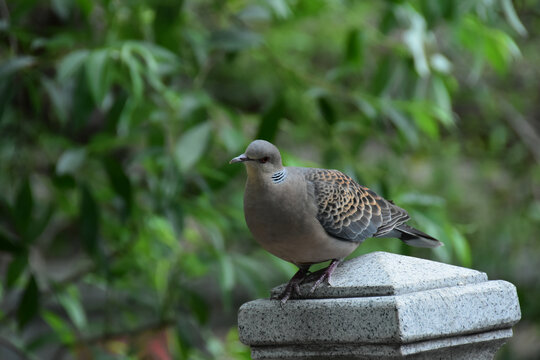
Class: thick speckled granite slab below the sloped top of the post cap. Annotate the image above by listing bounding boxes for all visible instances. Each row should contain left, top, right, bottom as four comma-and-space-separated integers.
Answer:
238, 280, 521, 345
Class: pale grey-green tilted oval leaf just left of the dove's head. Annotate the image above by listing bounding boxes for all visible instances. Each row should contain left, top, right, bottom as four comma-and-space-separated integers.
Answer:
174, 122, 212, 172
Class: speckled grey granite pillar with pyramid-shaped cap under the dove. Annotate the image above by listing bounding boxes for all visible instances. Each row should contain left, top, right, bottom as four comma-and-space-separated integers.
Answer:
238, 252, 521, 360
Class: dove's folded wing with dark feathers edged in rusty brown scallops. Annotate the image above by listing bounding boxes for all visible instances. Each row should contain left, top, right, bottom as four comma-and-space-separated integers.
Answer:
304, 168, 409, 242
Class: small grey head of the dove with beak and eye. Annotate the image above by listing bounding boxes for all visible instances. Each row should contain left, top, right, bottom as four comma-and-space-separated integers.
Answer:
229, 140, 283, 174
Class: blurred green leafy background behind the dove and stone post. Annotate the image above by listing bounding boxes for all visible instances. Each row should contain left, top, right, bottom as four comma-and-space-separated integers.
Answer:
0, 0, 540, 360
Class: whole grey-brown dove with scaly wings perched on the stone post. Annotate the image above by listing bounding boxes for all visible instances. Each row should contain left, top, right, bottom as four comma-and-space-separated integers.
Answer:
229, 140, 443, 304
